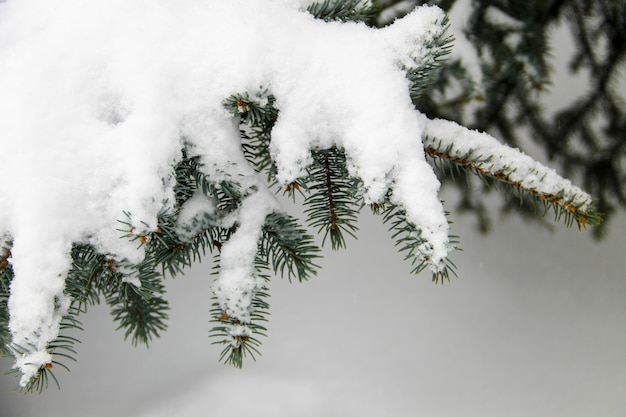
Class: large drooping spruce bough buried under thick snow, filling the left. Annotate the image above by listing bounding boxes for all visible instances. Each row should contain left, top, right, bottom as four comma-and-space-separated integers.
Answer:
0, 0, 600, 390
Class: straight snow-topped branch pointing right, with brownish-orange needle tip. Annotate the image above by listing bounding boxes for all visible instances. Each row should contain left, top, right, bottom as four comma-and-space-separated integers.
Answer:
422, 119, 602, 228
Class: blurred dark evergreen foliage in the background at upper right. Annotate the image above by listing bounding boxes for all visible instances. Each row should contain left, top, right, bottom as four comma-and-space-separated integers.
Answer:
375, 0, 626, 237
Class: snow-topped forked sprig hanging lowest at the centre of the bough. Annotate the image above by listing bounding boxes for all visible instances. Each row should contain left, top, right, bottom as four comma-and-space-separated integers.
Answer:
211, 191, 319, 367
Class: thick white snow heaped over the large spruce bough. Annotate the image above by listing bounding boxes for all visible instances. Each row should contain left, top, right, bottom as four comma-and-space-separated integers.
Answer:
0, 0, 448, 384
